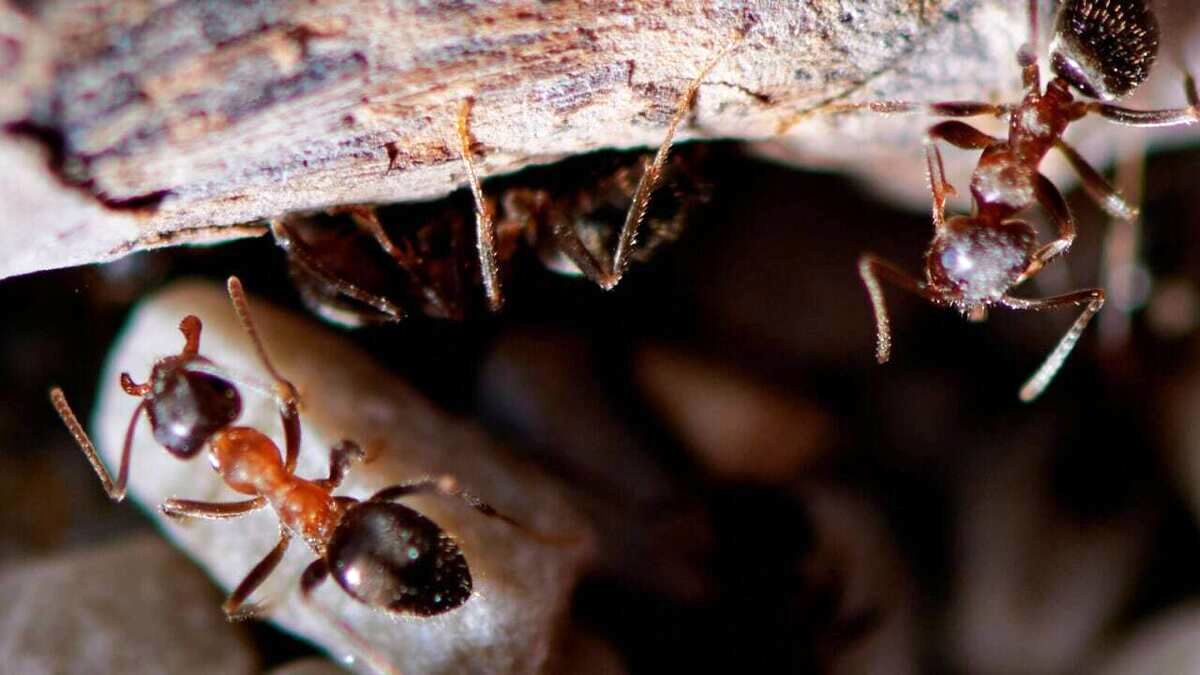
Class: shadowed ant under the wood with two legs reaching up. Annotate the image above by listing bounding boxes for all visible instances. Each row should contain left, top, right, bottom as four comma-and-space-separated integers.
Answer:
271, 37, 740, 325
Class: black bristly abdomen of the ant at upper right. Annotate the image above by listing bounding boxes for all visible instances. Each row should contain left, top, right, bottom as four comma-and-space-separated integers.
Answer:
1050, 0, 1158, 101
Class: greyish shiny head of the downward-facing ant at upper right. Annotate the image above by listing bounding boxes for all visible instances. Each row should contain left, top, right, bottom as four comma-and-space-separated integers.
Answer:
925, 216, 1037, 307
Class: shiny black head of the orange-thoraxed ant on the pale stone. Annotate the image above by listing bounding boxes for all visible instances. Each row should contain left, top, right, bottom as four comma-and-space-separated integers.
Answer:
142, 354, 241, 459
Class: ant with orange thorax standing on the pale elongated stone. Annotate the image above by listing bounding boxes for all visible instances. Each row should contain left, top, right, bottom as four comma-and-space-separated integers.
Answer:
50, 276, 550, 671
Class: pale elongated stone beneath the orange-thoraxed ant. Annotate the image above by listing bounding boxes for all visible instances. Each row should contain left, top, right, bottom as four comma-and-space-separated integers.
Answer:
91, 276, 593, 674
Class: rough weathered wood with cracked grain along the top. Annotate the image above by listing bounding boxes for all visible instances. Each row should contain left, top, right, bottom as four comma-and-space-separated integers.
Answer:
0, 0, 1195, 277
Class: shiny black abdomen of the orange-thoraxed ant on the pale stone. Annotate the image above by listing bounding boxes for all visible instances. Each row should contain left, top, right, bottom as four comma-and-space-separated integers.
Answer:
325, 502, 472, 616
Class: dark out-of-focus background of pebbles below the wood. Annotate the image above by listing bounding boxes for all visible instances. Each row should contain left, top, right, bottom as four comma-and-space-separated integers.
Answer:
7, 138, 1200, 673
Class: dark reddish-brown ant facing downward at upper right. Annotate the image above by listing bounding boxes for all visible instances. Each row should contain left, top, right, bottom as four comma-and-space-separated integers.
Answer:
834, 0, 1200, 401
